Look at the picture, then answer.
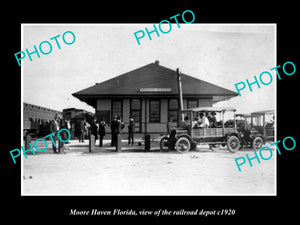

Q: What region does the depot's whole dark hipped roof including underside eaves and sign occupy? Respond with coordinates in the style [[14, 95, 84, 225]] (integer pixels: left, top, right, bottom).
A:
[[72, 61, 238, 107]]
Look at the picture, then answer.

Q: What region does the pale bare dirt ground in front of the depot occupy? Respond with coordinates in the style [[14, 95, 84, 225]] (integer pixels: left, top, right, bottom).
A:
[[21, 137, 276, 196]]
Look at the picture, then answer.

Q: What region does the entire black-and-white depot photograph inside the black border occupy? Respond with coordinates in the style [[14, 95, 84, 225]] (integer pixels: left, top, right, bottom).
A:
[[21, 23, 276, 196]]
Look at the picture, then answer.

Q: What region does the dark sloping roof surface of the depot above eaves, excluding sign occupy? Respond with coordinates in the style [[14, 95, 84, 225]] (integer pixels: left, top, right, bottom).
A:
[[73, 63, 237, 97]]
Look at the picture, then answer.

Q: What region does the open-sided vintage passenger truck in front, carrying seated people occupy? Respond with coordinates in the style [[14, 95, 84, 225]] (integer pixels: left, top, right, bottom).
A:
[[160, 107, 241, 153]]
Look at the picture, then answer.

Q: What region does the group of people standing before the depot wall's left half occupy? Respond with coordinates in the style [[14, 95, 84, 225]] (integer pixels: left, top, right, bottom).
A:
[[79, 116, 135, 147]]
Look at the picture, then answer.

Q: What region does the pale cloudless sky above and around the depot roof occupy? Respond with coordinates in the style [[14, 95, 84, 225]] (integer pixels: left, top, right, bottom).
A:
[[22, 22, 277, 113]]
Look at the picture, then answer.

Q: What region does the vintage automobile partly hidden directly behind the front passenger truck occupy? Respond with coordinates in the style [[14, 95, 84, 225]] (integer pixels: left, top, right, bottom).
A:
[[235, 113, 265, 150]]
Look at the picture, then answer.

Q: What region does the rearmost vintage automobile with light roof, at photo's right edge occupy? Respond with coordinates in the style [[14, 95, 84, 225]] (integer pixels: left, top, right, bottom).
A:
[[251, 110, 275, 141]]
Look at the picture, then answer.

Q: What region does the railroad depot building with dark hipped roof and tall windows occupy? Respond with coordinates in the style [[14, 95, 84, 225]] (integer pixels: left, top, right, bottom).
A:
[[72, 61, 238, 133]]
